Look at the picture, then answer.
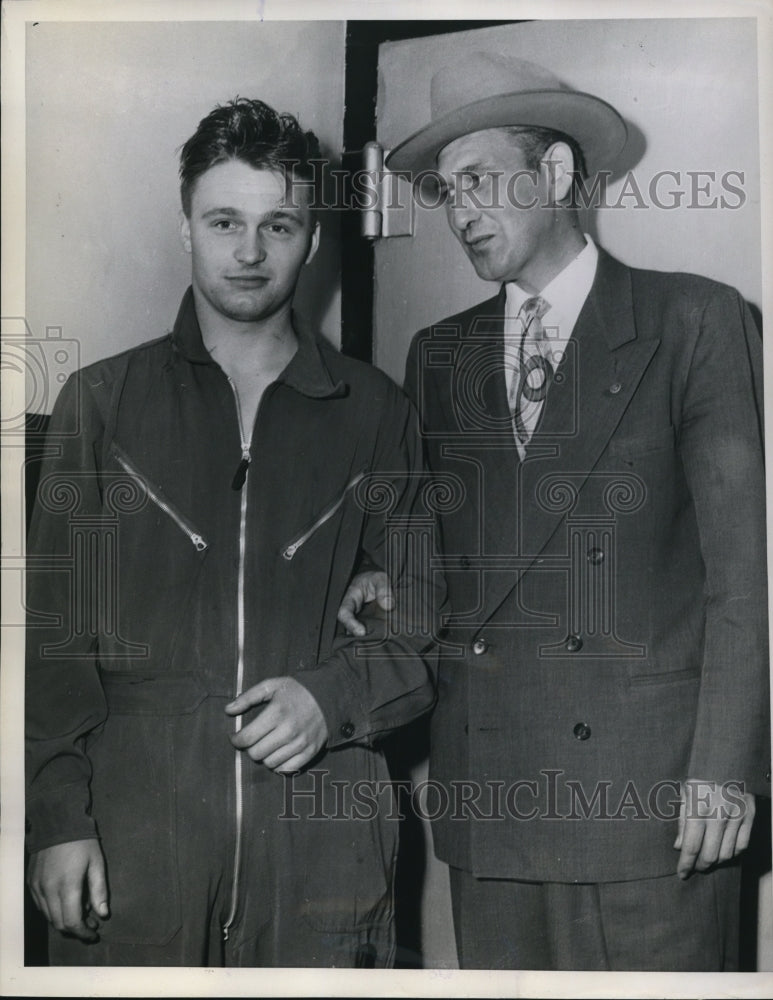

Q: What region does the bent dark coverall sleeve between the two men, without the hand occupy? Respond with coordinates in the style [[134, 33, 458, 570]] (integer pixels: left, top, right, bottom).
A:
[[296, 387, 445, 747]]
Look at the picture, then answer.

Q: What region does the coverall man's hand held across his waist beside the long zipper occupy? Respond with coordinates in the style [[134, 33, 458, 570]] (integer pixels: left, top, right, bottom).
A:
[[225, 677, 328, 774]]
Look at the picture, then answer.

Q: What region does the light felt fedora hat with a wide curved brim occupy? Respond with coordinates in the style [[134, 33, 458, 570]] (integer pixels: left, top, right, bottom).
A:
[[386, 52, 627, 174]]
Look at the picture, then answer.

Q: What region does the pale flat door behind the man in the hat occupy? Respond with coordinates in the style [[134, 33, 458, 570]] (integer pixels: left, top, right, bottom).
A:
[[373, 13, 773, 968]]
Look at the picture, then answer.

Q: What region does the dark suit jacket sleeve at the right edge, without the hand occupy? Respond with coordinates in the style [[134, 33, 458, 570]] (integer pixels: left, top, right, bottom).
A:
[[679, 287, 770, 794]]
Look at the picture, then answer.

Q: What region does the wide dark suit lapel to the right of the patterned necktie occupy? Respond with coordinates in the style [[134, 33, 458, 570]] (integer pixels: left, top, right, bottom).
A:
[[483, 250, 659, 618]]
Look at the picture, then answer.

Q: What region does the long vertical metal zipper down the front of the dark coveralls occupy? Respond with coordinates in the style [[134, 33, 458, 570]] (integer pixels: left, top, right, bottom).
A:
[[223, 376, 253, 941]]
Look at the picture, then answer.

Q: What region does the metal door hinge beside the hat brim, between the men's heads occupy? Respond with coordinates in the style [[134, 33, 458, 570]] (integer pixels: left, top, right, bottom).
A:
[[357, 142, 414, 240]]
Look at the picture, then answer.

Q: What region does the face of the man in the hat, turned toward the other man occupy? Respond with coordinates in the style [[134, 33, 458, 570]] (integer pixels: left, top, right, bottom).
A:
[[438, 129, 558, 291]]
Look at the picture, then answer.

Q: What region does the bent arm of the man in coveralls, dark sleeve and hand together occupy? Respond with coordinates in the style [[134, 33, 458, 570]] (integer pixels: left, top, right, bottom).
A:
[[227, 389, 444, 771]]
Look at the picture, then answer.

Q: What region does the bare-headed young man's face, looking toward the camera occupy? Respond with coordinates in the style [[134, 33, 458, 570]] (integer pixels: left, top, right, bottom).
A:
[[182, 160, 319, 323]]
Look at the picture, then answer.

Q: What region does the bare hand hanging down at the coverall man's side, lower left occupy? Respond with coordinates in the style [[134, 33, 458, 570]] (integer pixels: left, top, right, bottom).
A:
[[27, 840, 110, 941]]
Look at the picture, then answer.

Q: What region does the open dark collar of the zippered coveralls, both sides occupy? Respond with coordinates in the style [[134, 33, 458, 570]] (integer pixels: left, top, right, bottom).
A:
[[172, 288, 347, 398]]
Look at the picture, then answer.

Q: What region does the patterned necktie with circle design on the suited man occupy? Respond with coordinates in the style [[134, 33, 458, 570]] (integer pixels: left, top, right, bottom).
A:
[[509, 295, 553, 459]]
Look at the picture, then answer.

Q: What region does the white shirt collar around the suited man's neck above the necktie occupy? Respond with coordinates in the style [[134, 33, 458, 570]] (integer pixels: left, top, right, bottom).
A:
[[505, 233, 599, 354]]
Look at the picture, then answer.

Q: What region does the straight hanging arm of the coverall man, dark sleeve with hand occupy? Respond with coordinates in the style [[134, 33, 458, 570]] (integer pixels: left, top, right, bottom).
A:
[[26, 374, 107, 908]]
